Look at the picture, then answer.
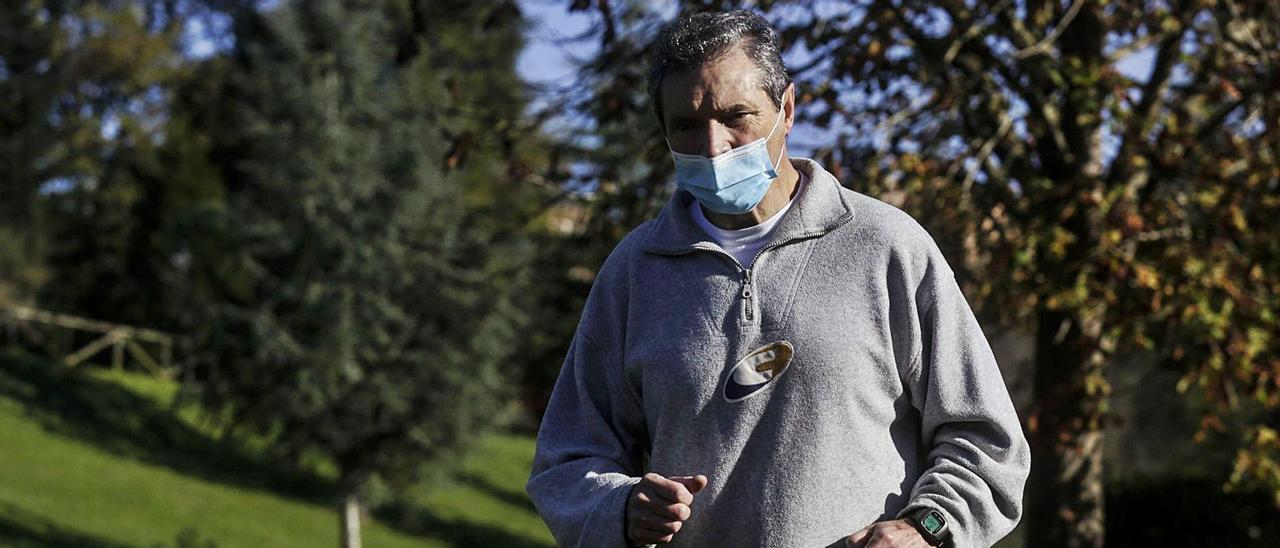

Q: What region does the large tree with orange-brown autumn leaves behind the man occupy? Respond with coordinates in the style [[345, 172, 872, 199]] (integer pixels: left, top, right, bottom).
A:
[[573, 0, 1280, 545]]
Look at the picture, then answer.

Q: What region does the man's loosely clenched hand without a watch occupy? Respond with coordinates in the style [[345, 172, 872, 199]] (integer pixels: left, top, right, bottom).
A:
[[626, 472, 707, 545]]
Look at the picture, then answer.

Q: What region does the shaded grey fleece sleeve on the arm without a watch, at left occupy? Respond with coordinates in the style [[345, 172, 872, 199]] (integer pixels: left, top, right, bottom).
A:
[[525, 326, 648, 548]]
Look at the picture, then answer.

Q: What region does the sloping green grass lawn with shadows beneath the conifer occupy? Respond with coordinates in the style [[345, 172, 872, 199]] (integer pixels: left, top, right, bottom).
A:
[[0, 352, 552, 548]]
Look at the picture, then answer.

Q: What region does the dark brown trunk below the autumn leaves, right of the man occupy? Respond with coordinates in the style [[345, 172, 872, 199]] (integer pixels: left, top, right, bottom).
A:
[[1027, 311, 1110, 548]]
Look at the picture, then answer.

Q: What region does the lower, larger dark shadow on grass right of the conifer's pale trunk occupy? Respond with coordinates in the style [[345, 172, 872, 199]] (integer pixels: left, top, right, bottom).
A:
[[372, 503, 548, 548]]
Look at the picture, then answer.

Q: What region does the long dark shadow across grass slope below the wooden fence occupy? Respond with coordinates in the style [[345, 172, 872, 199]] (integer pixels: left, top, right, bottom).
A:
[[0, 351, 334, 504]]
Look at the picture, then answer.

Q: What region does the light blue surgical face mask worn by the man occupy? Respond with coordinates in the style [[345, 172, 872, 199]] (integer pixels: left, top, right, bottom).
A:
[[668, 109, 786, 215]]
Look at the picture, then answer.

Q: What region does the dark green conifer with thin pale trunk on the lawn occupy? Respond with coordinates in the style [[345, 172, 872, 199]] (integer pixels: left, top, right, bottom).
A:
[[189, 0, 529, 547]]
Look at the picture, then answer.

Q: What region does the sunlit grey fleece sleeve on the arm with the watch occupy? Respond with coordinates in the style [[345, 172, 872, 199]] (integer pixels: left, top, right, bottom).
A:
[[899, 251, 1030, 548]]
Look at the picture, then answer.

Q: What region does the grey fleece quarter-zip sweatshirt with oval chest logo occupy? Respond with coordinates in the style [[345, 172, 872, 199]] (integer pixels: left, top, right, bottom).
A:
[[526, 159, 1030, 547]]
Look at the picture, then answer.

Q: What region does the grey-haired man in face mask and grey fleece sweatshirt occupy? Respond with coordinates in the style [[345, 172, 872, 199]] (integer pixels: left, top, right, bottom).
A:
[[527, 12, 1030, 547]]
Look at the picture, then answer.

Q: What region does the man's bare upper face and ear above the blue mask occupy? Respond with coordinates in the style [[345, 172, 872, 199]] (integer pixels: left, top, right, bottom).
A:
[[662, 47, 792, 157]]
